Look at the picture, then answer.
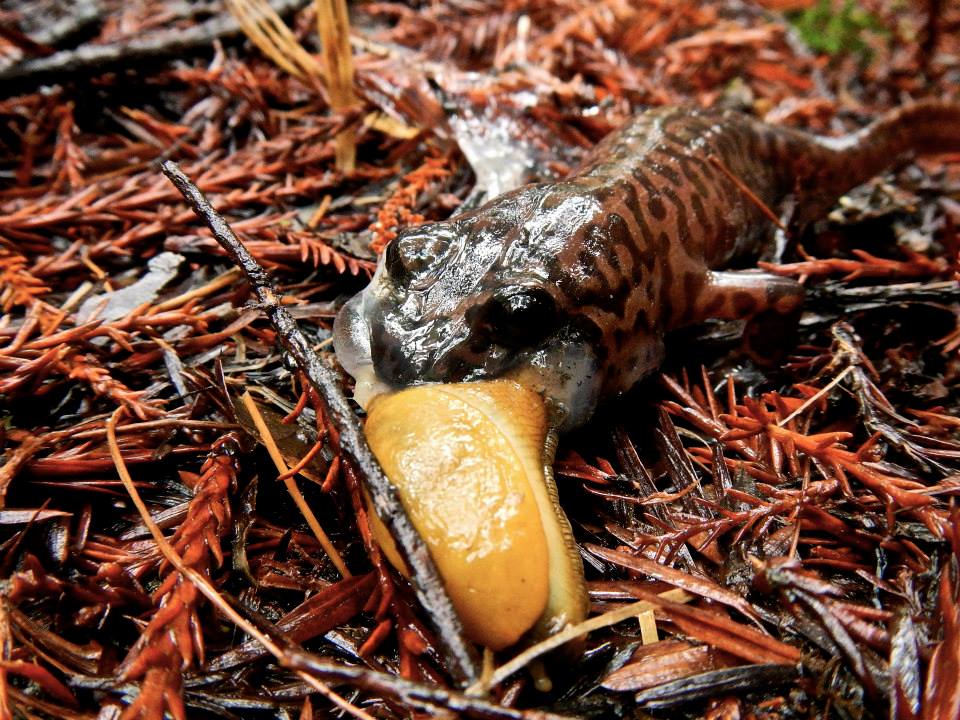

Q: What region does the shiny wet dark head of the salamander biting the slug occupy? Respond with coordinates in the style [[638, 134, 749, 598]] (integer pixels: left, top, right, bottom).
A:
[[334, 183, 664, 429]]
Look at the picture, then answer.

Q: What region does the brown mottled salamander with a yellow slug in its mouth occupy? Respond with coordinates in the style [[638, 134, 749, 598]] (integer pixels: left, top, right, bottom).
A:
[[334, 101, 960, 429]]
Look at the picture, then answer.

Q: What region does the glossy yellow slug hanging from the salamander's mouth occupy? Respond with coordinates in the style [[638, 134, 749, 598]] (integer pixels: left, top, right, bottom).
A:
[[366, 380, 586, 650]]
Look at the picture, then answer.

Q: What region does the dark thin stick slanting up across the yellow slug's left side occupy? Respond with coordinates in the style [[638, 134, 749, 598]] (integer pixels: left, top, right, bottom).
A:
[[161, 160, 479, 684]]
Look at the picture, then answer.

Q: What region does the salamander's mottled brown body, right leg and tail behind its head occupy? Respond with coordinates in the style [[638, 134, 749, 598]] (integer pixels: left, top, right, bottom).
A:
[[558, 102, 960, 392]]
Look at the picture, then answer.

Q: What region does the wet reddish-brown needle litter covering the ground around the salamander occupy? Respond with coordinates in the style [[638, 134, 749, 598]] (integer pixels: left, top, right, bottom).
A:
[[0, 0, 960, 720]]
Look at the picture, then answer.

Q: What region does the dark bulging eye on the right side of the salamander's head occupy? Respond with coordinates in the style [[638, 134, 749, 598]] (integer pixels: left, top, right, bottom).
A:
[[481, 289, 560, 348]]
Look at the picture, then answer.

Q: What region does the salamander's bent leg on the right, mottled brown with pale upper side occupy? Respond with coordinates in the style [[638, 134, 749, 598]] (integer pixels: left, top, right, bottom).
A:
[[698, 270, 804, 365]]
